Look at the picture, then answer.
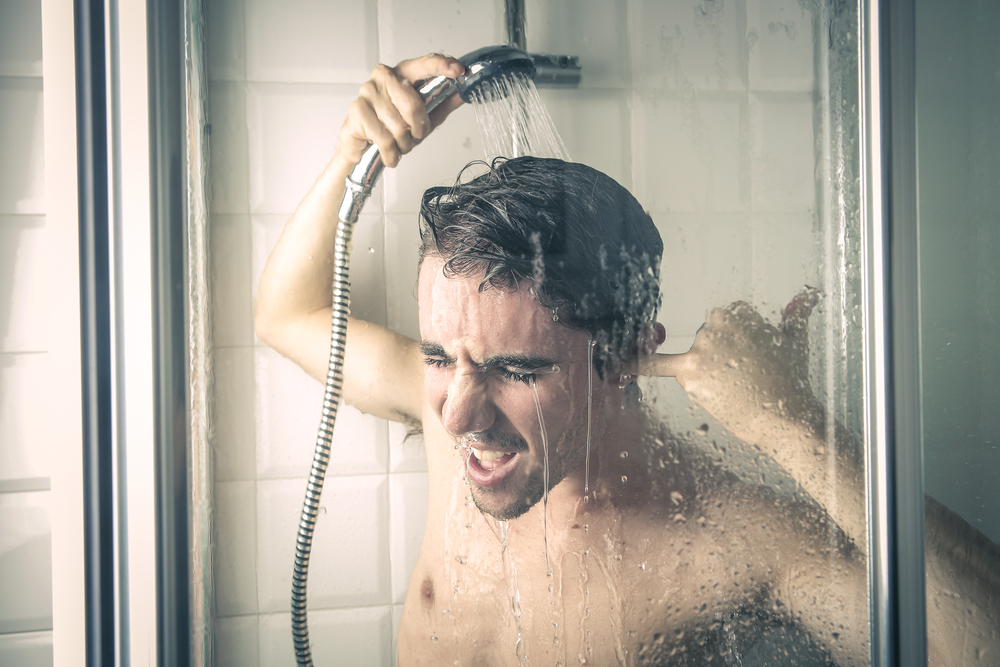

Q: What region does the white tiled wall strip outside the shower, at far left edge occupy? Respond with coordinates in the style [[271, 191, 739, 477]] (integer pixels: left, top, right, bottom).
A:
[[0, 0, 56, 667]]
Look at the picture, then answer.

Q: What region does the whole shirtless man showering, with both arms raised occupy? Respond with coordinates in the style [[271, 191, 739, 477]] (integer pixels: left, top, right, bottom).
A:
[[256, 55, 1000, 665]]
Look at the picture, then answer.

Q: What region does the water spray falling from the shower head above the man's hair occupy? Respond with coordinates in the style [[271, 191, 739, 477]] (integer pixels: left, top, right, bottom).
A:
[[472, 74, 569, 160]]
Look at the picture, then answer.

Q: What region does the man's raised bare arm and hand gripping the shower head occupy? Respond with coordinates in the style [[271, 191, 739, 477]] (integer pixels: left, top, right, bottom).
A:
[[254, 55, 465, 421]]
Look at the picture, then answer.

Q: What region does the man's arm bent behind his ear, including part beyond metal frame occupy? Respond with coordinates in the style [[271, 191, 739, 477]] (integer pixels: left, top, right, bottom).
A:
[[641, 290, 1000, 666]]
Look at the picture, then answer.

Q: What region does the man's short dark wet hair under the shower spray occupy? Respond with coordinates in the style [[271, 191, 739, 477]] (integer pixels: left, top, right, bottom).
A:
[[420, 156, 663, 377]]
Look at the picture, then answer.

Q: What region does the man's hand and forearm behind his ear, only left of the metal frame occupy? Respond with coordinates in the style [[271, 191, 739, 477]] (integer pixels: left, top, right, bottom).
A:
[[641, 289, 867, 551]]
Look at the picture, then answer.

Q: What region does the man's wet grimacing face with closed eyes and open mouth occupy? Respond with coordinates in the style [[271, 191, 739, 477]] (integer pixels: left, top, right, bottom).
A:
[[418, 256, 605, 520]]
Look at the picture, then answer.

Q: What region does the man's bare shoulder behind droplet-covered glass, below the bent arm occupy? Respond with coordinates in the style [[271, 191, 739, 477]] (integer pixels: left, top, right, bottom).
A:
[[620, 417, 867, 665]]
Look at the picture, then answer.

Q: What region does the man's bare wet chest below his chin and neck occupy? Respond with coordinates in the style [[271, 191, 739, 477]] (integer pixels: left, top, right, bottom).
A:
[[400, 488, 766, 665]]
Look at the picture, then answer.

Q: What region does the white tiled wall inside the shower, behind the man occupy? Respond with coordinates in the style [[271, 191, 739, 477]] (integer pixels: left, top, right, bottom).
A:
[[207, 0, 828, 666]]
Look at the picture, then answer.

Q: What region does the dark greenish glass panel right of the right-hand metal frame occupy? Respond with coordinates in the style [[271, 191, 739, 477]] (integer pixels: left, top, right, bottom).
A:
[[916, 0, 1000, 664]]
